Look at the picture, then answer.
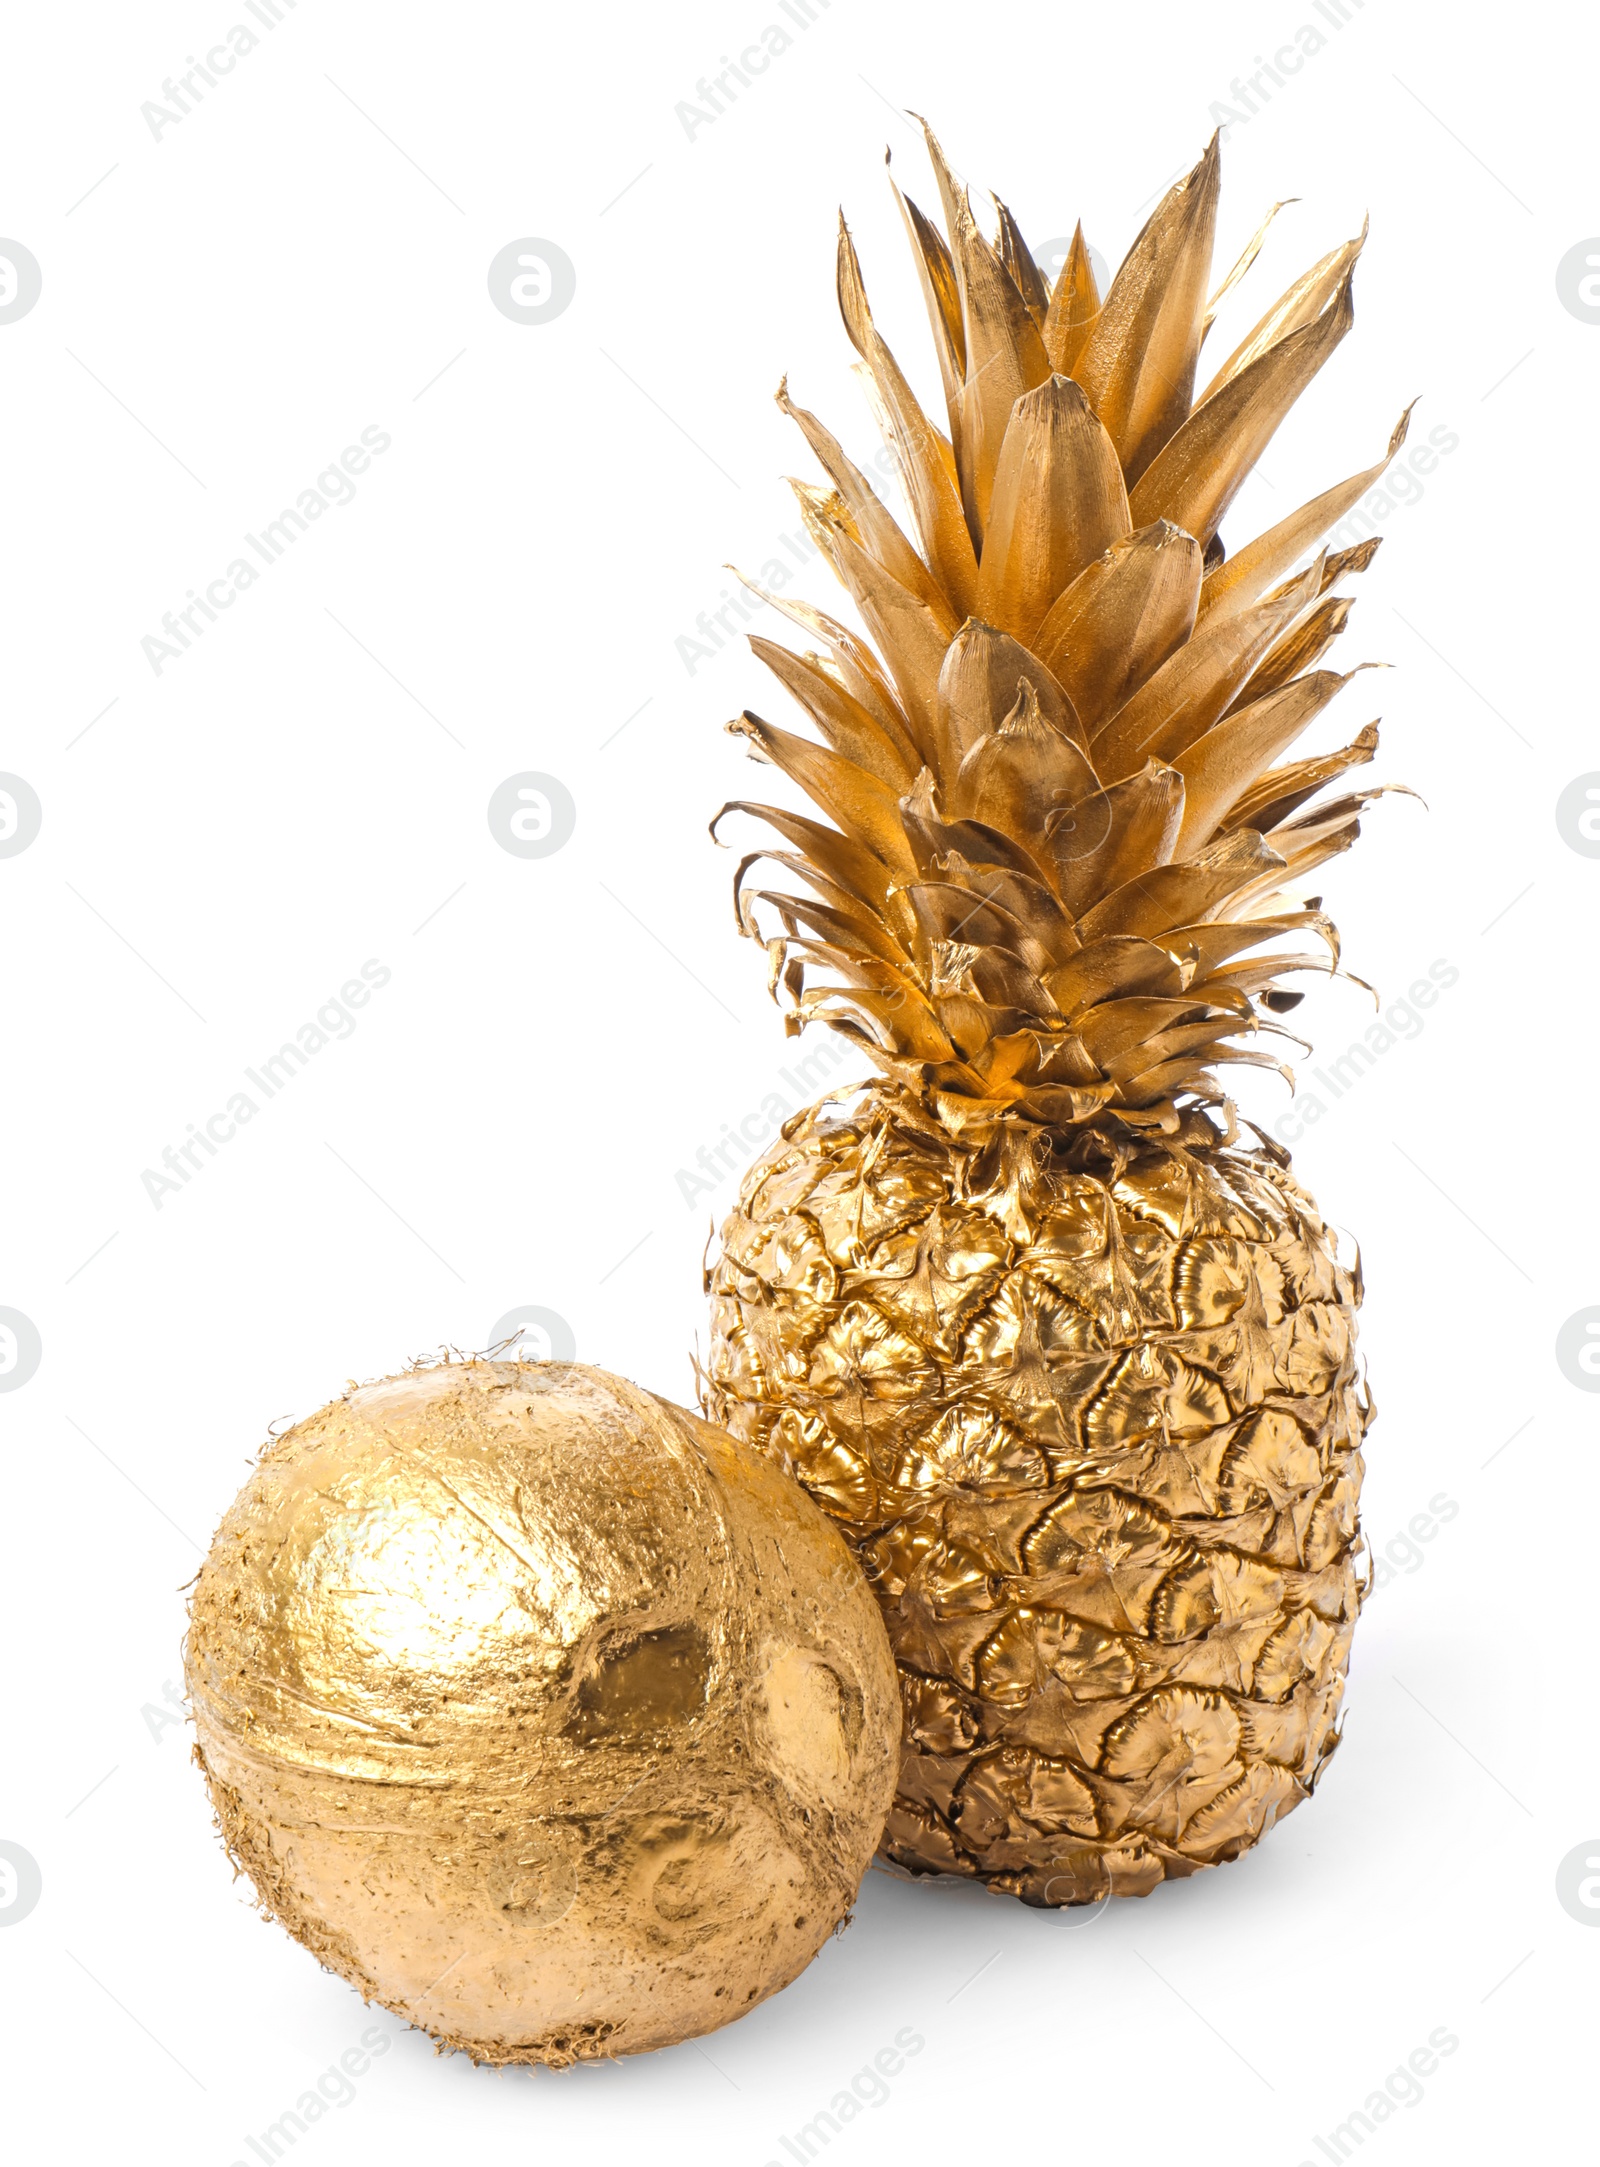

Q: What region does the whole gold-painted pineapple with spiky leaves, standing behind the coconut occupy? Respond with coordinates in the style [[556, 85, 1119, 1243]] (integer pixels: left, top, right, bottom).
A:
[[707, 137, 1405, 1905]]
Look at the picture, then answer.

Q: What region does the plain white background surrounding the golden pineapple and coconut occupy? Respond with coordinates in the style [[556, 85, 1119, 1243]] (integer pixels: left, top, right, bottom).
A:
[[0, 0, 1600, 2167]]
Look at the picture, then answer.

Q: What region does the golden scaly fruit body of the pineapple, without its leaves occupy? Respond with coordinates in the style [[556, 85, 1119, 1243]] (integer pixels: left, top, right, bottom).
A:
[[709, 1088, 1370, 1905]]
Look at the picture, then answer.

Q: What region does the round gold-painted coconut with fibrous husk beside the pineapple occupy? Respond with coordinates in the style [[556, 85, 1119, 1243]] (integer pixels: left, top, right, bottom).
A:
[[184, 1361, 900, 2065]]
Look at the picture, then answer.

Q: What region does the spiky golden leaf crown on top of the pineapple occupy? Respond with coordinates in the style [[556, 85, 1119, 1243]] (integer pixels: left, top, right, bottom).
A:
[[711, 128, 1409, 1136]]
